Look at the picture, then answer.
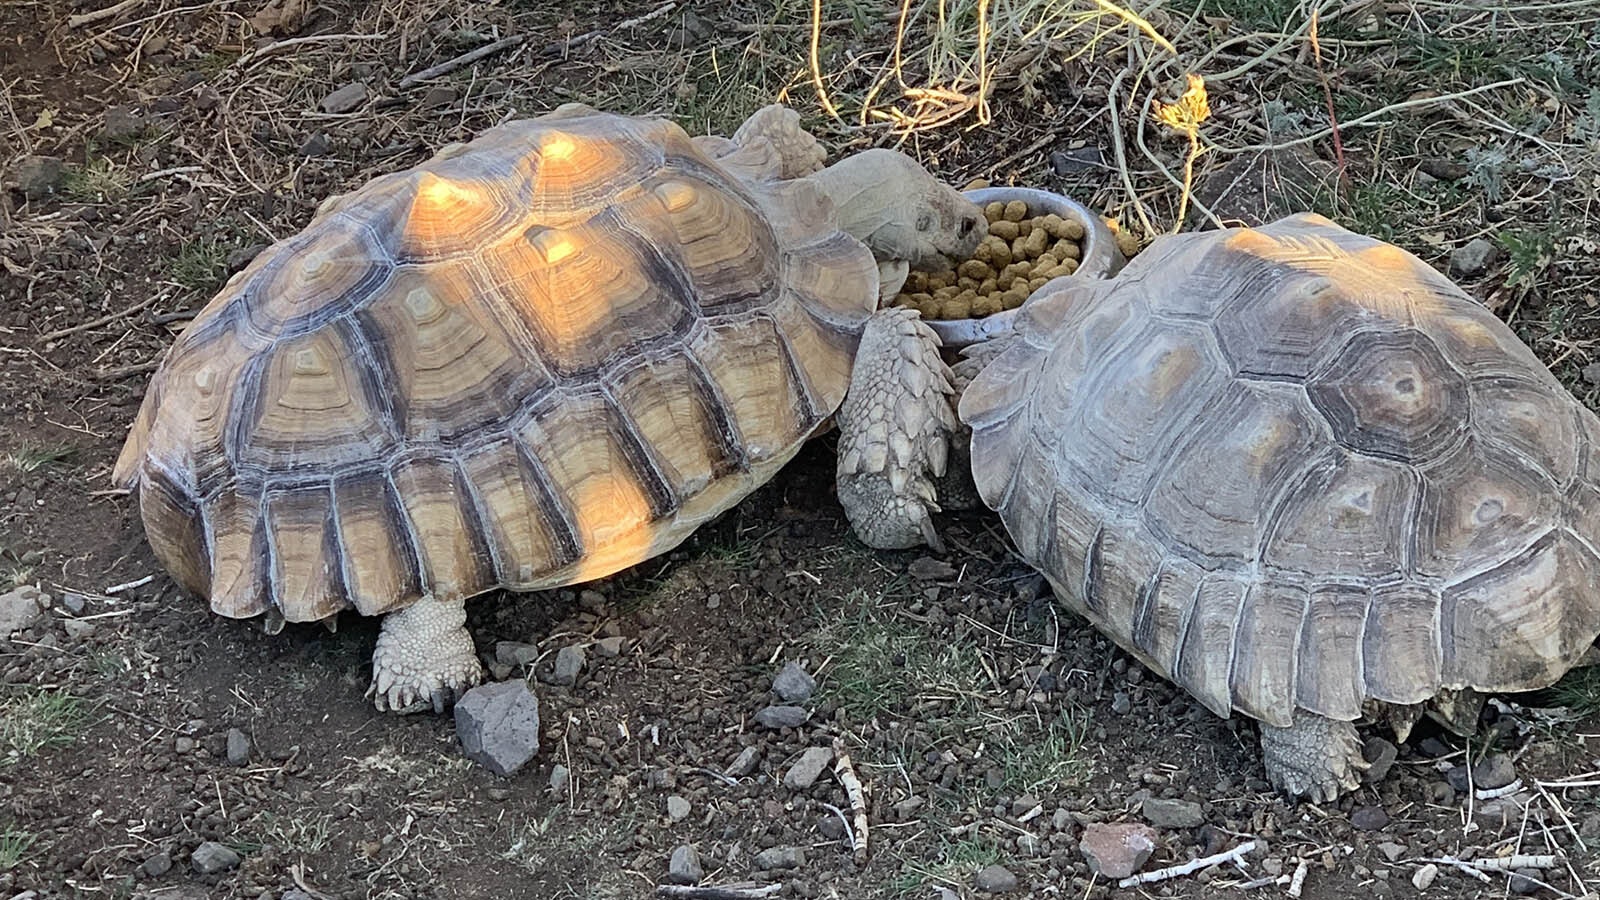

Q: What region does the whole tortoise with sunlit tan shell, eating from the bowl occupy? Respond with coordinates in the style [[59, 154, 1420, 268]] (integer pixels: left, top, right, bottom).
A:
[[114, 104, 986, 713]]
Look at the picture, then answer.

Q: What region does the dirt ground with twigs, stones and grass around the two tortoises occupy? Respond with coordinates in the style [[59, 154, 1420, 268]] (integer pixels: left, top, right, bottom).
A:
[[0, 0, 1600, 900]]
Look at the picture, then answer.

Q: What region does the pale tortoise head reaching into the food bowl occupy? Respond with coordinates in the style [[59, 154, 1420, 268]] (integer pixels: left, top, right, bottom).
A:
[[810, 149, 989, 269]]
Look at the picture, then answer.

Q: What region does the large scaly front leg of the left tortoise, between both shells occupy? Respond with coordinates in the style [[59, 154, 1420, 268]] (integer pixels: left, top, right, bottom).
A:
[[837, 307, 955, 549]]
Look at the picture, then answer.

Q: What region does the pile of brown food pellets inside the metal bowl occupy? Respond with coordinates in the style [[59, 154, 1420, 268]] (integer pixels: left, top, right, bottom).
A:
[[890, 200, 1083, 319]]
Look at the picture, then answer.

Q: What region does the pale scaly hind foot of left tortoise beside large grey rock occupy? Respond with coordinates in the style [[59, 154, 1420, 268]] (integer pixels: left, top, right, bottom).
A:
[[366, 597, 483, 713]]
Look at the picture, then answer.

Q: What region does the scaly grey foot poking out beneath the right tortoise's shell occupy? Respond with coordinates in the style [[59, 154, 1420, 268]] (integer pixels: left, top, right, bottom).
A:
[[1261, 709, 1366, 802]]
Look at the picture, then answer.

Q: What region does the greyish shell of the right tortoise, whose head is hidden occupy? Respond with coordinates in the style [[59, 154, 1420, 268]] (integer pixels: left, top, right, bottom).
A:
[[962, 215, 1600, 727]]
